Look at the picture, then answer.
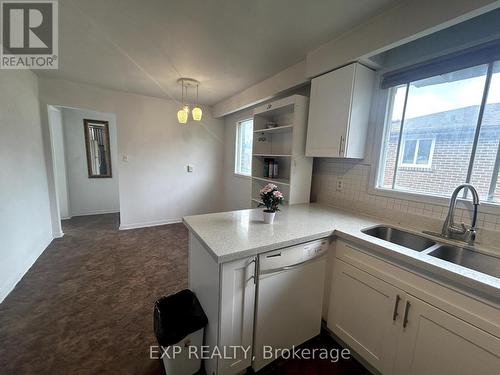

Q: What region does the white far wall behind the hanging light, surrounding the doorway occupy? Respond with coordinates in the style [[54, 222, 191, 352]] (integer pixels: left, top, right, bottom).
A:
[[39, 78, 224, 229]]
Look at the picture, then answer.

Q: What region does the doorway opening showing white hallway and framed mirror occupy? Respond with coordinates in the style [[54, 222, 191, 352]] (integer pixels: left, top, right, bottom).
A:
[[47, 105, 120, 234]]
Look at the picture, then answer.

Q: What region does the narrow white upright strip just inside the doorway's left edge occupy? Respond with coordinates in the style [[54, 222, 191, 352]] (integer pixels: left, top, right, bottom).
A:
[[48, 106, 71, 219]]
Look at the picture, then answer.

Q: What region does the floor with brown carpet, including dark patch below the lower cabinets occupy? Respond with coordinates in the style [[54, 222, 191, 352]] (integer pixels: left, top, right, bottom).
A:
[[0, 214, 368, 375]]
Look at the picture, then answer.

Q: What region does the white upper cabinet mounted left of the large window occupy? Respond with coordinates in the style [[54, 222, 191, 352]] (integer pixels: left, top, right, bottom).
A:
[[306, 63, 375, 159]]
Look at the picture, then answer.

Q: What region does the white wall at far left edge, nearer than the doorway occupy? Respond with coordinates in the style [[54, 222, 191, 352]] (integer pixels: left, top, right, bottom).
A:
[[0, 70, 52, 302]]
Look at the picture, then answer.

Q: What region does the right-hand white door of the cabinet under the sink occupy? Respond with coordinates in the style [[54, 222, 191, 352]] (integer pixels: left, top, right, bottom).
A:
[[394, 295, 500, 375]]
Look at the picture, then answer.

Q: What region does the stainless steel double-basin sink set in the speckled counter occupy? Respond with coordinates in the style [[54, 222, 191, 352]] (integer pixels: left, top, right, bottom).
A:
[[361, 225, 500, 278]]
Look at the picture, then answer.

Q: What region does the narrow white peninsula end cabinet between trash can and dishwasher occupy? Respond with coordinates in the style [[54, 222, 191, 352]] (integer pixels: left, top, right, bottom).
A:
[[189, 232, 256, 375]]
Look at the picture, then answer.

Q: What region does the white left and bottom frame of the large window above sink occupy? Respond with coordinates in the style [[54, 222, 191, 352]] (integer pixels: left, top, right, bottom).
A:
[[370, 62, 500, 215]]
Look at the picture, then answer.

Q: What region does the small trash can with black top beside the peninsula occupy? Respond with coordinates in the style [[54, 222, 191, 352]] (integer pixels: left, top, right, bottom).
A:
[[153, 289, 208, 375]]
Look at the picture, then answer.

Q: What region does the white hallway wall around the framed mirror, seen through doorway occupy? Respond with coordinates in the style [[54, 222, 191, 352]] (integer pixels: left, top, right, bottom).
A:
[[61, 108, 120, 216]]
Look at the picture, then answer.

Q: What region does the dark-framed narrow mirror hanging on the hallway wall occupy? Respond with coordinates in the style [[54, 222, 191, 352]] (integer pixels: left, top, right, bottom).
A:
[[83, 119, 112, 178]]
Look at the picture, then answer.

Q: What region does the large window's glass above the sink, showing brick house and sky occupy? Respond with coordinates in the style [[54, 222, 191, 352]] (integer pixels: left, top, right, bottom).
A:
[[378, 62, 500, 203]]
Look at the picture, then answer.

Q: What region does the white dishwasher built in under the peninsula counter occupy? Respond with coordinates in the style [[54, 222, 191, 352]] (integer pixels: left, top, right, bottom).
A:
[[252, 238, 330, 371]]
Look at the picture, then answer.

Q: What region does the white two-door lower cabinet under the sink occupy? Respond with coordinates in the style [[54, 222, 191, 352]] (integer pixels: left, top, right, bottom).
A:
[[327, 241, 500, 375]]
